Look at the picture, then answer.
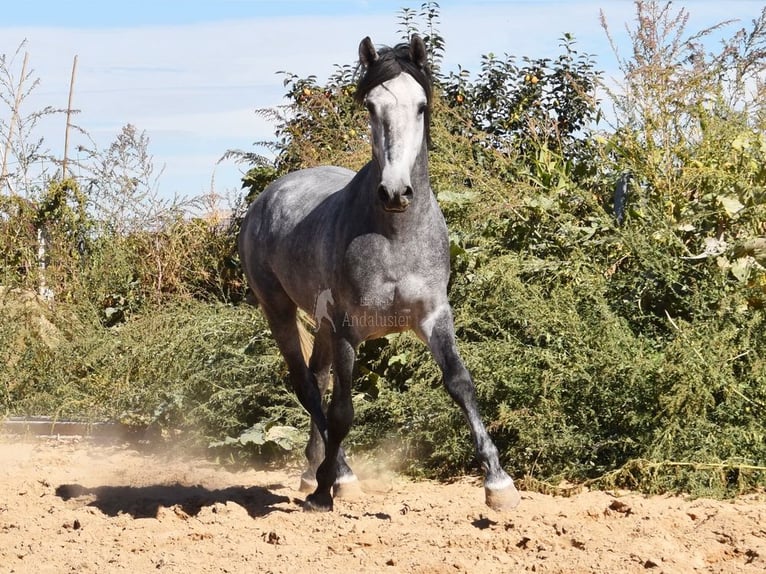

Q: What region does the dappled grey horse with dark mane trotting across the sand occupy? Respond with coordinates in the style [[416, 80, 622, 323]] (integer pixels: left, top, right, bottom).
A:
[[238, 35, 520, 511]]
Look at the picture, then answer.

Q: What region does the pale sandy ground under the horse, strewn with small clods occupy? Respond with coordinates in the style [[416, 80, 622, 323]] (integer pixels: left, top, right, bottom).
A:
[[0, 437, 766, 574]]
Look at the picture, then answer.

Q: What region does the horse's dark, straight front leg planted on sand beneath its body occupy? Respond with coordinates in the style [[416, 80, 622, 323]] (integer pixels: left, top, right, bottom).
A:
[[305, 336, 356, 512]]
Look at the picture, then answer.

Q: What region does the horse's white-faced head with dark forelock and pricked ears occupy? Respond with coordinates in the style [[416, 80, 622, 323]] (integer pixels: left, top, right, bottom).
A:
[[356, 35, 432, 212]]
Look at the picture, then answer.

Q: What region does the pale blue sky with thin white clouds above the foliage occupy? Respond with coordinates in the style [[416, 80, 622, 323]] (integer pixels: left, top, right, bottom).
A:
[[0, 0, 763, 204]]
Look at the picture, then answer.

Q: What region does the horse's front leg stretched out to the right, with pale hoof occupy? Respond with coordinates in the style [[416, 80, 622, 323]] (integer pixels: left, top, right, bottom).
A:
[[418, 304, 520, 510]]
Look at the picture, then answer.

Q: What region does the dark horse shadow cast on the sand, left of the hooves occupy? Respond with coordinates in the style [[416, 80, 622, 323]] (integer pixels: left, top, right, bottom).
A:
[[56, 483, 294, 518]]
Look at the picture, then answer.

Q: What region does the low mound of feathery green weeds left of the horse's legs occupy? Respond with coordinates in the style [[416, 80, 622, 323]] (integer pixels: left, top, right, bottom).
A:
[[4, 301, 307, 452]]
